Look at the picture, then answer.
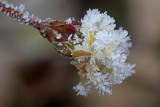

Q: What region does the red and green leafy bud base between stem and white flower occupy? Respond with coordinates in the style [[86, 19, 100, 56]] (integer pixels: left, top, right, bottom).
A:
[[39, 20, 83, 58]]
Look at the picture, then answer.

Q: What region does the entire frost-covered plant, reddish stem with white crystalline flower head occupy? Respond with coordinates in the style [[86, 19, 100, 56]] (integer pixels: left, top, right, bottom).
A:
[[0, 0, 135, 96]]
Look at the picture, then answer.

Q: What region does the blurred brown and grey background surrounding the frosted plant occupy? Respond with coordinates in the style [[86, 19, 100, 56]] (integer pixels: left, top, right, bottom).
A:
[[0, 0, 160, 107]]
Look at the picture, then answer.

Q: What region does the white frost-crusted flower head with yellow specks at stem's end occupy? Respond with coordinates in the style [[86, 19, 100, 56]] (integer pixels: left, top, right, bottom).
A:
[[72, 9, 135, 96]]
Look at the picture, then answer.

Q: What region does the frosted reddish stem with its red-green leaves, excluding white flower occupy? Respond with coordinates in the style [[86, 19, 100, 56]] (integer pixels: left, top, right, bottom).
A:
[[0, 0, 82, 57]]
